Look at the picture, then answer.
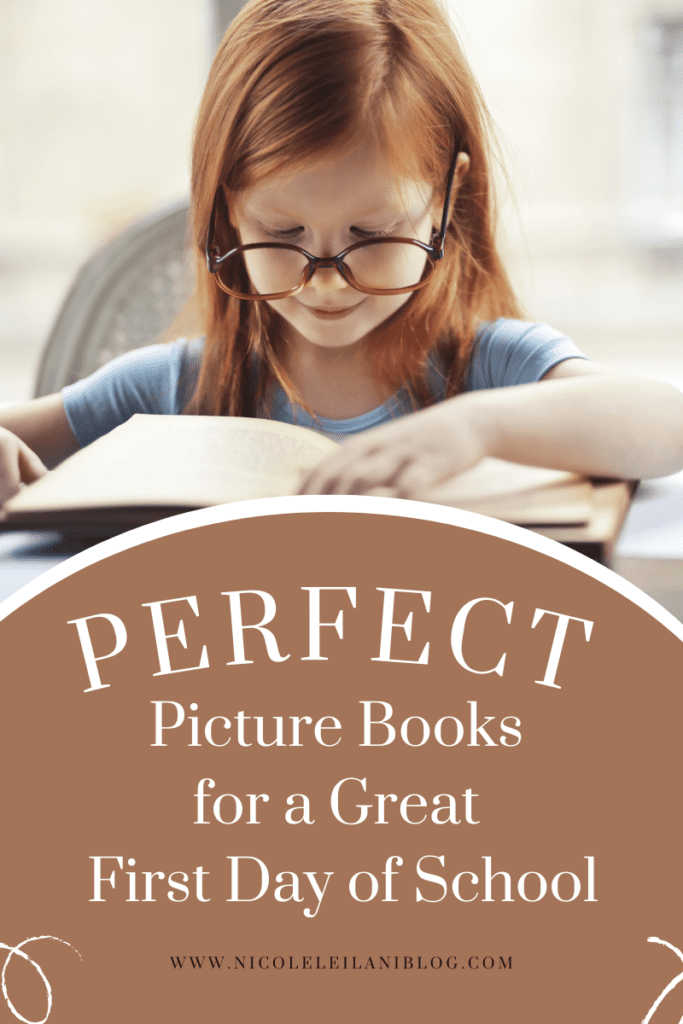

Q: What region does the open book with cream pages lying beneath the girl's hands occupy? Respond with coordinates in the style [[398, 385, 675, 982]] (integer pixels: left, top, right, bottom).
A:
[[2, 415, 592, 535]]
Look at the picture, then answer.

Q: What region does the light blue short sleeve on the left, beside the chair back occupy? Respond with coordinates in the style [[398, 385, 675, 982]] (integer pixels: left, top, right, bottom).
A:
[[61, 338, 203, 447]]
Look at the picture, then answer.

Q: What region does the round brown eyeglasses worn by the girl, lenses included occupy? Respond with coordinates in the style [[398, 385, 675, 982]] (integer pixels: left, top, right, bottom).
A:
[[206, 145, 460, 302]]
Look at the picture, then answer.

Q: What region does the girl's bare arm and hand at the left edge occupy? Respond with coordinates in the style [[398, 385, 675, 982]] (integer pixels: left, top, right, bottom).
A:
[[0, 394, 79, 504]]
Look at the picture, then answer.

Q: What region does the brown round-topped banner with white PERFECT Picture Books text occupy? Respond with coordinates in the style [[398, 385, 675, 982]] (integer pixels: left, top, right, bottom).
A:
[[0, 512, 683, 1024]]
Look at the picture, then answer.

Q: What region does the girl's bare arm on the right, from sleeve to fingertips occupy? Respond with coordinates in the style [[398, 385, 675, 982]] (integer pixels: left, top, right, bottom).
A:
[[302, 359, 683, 498]]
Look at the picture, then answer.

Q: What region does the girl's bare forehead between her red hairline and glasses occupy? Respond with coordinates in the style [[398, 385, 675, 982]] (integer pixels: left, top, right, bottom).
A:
[[237, 140, 432, 216]]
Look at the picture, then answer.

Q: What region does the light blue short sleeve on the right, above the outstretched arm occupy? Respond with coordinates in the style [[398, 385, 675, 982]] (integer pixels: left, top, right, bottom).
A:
[[466, 317, 586, 391]]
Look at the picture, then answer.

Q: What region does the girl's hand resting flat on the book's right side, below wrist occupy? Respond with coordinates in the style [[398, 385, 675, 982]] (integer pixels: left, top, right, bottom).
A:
[[300, 397, 488, 498]]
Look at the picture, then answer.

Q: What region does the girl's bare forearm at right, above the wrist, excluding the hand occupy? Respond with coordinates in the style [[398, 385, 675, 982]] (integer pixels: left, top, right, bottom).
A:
[[453, 374, 683, 479]]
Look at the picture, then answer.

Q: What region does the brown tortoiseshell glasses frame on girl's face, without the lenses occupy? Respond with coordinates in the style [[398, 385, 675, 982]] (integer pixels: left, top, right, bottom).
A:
[[206, 145, 460, 302]]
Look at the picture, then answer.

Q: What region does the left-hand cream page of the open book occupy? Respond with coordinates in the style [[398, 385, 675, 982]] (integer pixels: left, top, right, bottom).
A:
[[5, 415, 337, 513]]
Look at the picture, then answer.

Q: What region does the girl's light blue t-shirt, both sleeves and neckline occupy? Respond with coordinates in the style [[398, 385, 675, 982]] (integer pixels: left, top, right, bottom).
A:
[[62, 317, 585, 447]]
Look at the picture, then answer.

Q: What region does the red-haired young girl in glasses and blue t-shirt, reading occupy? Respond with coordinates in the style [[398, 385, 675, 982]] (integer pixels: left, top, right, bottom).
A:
[[0, 0, 683, 501]]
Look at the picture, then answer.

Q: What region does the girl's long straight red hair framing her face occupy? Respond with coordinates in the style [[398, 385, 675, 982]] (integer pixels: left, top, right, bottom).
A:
[[188, 0, 520, 416]]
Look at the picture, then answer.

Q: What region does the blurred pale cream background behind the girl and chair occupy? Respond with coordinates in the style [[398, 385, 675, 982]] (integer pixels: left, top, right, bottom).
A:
[[0, 0, 683, 401]]
